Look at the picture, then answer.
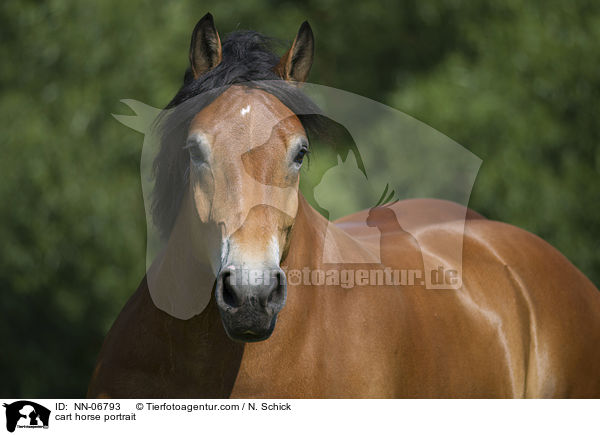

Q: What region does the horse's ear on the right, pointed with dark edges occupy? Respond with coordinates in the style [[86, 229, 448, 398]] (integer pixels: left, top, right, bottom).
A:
[[275, 21, 315, 83]]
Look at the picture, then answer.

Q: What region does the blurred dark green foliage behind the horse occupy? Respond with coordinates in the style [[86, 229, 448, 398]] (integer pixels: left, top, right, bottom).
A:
[[0, 0, 600, 397]]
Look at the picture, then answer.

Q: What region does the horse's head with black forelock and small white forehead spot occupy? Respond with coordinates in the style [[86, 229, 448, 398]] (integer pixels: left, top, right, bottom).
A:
[[153, 14, 313, 341]]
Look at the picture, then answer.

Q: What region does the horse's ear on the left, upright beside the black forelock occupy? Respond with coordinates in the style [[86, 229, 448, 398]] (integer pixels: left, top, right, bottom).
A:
[[190, 13, 221, 79]]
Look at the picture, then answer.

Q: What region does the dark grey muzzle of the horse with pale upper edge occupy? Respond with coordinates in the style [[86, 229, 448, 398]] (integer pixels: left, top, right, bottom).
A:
[[215, 265, 287, 342]]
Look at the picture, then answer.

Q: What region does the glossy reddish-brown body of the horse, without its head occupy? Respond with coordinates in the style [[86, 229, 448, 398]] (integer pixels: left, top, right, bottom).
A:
[[88, 199, 600, 398]]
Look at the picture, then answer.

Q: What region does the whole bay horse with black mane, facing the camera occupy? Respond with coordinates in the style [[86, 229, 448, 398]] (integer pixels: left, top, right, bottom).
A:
[[88, 14, 600, 398]]
